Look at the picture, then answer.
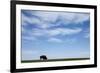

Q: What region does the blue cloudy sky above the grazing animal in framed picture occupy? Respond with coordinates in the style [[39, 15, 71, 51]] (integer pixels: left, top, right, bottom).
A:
[[21, 10, 90, 60]]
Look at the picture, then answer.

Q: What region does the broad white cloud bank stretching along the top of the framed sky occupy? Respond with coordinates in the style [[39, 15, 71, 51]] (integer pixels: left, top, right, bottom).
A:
[[22, 11, 89, 29]]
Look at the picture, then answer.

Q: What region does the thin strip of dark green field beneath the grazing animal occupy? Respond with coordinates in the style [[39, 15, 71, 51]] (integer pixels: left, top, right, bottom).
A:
[[21, 58, 90, 63]]
